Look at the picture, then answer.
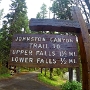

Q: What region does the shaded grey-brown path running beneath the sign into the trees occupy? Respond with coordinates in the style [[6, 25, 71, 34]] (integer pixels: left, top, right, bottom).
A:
[[0, 72, 58, 90]]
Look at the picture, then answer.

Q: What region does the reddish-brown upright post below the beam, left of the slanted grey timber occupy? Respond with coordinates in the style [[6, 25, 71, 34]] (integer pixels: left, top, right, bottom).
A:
[[78, 34, 90, 90]]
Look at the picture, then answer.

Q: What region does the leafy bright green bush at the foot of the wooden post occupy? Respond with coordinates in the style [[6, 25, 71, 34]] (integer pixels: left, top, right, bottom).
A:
[[61, 81, 82, 90]]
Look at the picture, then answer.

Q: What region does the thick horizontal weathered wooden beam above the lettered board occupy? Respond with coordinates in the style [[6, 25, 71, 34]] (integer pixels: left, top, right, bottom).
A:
[[29, 18, 90, 33]]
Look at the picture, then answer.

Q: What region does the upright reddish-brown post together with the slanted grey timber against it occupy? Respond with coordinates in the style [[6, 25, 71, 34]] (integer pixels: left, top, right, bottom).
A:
[[73, 7, 90, 90]]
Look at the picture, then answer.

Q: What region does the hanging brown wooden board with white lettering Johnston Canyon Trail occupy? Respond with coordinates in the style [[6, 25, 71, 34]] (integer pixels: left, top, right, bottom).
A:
[[9, 34, 79, 68]]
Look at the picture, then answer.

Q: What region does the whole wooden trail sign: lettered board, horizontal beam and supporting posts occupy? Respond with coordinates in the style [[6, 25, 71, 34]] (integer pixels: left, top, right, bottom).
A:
[[9, 7, 90, 90]]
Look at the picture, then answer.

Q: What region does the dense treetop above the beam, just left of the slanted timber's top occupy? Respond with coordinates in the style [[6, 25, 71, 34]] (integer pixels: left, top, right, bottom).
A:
[[50, 0, 71, 20]]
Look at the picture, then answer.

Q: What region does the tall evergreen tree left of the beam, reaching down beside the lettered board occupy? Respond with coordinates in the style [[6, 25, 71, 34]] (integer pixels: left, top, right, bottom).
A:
[[0, 0, 29, 65]]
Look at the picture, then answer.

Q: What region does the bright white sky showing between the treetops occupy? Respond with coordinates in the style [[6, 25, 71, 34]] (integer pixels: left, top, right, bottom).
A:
[[0, 0, 51, 19]]
